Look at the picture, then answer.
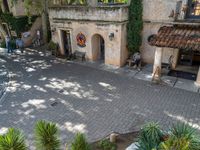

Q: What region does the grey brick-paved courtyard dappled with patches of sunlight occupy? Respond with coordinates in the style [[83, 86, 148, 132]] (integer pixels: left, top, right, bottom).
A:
[[0, 52, 200, 148]]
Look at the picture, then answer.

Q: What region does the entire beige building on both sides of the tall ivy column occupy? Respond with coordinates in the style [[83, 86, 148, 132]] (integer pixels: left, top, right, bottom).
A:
[[49, 0, 200, 85]]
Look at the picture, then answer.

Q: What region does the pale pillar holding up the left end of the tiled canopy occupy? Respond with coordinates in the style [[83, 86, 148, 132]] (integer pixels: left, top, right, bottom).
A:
[[153, 47, 163, 80]]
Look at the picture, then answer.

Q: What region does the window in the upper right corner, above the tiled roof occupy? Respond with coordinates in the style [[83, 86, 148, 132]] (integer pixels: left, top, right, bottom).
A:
[[188, 0, 200, 19]]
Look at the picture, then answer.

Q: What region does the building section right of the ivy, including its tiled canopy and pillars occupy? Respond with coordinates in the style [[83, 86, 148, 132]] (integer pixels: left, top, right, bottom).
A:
[[141, 0, 200, 85]]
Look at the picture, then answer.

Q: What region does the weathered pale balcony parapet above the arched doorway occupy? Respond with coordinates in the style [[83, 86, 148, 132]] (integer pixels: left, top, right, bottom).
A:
[[49, 4, 128, 22]]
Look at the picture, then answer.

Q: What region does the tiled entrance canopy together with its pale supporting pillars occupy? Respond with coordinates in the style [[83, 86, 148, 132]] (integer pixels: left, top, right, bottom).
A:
[[148, 25, 200, 86]]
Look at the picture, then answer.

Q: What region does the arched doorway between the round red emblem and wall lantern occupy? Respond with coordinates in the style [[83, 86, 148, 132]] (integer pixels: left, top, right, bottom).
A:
[[92, 34, 105, 62]]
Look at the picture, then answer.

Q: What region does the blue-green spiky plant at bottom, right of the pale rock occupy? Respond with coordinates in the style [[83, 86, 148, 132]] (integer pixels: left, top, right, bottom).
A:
[[137, 122, 163, 150]]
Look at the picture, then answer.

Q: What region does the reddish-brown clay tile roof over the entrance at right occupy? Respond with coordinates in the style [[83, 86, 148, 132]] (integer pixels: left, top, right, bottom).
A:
[[148, 25, 200, 51]]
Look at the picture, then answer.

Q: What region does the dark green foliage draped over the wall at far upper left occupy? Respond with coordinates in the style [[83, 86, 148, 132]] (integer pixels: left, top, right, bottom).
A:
[[0, 13, 36, 35]]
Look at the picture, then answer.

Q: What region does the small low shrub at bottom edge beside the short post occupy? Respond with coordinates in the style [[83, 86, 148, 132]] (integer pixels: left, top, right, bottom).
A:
[[98, 139, 117, 150]]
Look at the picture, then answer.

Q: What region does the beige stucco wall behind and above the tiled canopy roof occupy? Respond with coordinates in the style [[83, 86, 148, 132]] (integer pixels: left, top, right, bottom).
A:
[[141, 0, 187, 63]]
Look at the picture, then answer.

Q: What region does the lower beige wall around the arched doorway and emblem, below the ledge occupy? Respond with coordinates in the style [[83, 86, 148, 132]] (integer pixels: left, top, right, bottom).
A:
[[51, 21, 127, 66]]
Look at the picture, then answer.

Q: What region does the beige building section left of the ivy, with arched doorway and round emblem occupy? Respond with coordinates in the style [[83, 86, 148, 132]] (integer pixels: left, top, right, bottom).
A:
[[49, 0, 128, 66]]
